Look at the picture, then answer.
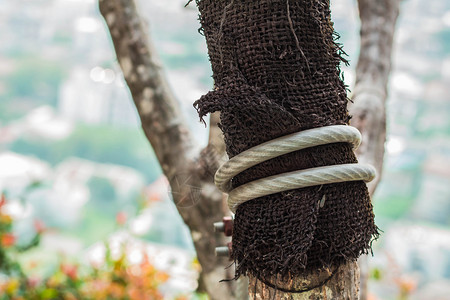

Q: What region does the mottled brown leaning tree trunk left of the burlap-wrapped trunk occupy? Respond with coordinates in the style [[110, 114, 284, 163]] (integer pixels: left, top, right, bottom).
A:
[[99, 0, 233, 299]]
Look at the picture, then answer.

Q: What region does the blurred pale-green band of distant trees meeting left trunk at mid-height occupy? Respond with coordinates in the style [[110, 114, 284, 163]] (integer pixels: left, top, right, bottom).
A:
[[10, 125, 161, 182]]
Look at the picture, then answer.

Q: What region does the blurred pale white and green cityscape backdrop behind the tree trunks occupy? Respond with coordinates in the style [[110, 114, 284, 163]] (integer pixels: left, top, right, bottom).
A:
[[0, 0, 450, 300]]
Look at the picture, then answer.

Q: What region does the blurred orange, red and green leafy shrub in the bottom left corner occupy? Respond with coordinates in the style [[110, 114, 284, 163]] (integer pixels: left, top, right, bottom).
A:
[[0, 194, 190, 300]]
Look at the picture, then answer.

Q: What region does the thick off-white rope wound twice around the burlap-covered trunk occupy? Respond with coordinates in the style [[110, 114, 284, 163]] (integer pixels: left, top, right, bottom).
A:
[[214, 125, 375, 212]]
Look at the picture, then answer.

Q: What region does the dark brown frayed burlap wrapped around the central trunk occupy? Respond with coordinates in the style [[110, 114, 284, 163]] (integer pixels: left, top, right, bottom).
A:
[[195, 0, 378, 277]]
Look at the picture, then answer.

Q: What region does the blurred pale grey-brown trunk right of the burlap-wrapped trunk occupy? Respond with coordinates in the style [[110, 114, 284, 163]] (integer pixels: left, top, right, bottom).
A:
[[349, 0, 400, 300]]
